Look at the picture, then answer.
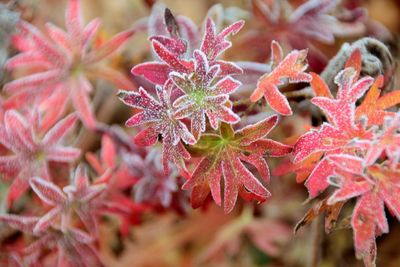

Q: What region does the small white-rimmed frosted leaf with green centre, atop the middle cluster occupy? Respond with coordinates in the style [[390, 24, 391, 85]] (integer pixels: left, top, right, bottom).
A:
[[170, 50, 240, 140]]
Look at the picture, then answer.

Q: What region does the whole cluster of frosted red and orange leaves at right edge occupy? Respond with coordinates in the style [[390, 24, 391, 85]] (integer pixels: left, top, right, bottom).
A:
[[292, 51, 400, 266]]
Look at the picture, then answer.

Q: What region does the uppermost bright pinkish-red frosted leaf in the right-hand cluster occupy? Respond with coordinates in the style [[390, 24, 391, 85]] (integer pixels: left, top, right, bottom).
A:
[[294, 68, 373, 162]]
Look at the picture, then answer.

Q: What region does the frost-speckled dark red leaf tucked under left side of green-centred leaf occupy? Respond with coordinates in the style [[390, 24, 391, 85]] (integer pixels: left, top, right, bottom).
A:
[[118, 80, 196, 174]]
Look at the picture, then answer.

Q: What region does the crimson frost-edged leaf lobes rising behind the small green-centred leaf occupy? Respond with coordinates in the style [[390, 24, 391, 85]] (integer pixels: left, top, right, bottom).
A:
[[131, 14, 244, 85]]
